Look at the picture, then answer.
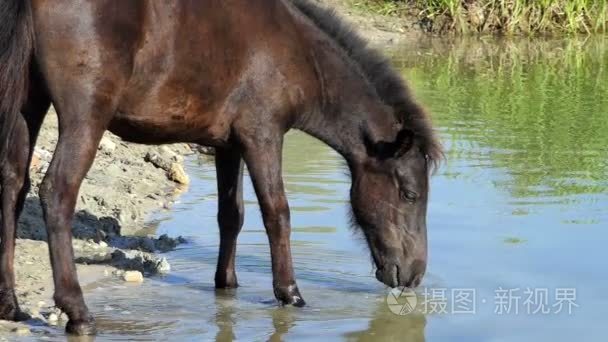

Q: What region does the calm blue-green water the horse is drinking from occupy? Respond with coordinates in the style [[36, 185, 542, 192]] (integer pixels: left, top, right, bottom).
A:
[[36, 38, 608, 341]]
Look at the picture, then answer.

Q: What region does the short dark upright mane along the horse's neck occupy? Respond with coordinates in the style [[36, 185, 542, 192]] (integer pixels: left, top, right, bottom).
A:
[[289, 0, 443, 169]]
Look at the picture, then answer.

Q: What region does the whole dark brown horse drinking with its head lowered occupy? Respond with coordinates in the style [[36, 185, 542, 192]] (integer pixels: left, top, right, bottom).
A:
[[0, 0, 441, 334]]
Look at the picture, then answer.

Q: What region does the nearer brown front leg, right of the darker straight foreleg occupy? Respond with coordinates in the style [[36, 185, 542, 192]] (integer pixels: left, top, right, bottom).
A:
[[241, 132, 306, 307]]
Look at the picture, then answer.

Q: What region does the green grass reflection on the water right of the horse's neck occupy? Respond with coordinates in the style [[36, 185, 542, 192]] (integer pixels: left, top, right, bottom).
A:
[[394, 37, 608, 201]]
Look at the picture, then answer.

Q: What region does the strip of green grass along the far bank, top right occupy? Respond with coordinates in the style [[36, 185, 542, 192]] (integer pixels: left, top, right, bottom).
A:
[[352, 0, 608, 35]]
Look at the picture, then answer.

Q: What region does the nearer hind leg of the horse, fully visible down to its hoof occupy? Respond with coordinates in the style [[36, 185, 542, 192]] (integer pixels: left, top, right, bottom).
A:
[[40, 110, 109, 335]]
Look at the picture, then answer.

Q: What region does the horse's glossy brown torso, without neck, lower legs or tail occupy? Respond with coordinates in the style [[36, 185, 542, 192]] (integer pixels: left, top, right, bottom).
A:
[[33, 0, 314, 145]]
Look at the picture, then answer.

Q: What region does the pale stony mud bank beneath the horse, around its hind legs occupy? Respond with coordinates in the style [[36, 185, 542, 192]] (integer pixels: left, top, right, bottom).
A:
[[0, 110, 192, 340]]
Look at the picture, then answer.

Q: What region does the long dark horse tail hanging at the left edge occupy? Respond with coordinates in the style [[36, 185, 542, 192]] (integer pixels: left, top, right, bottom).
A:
[[0, 0, 34, 165]]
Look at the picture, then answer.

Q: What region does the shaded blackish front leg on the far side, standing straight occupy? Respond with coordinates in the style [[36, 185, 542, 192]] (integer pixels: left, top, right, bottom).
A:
[[215, 148, 244, 288]]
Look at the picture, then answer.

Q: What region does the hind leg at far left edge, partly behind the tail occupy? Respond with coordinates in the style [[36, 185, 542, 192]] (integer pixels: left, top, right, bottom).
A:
[[0, 88, 50, 321]]
